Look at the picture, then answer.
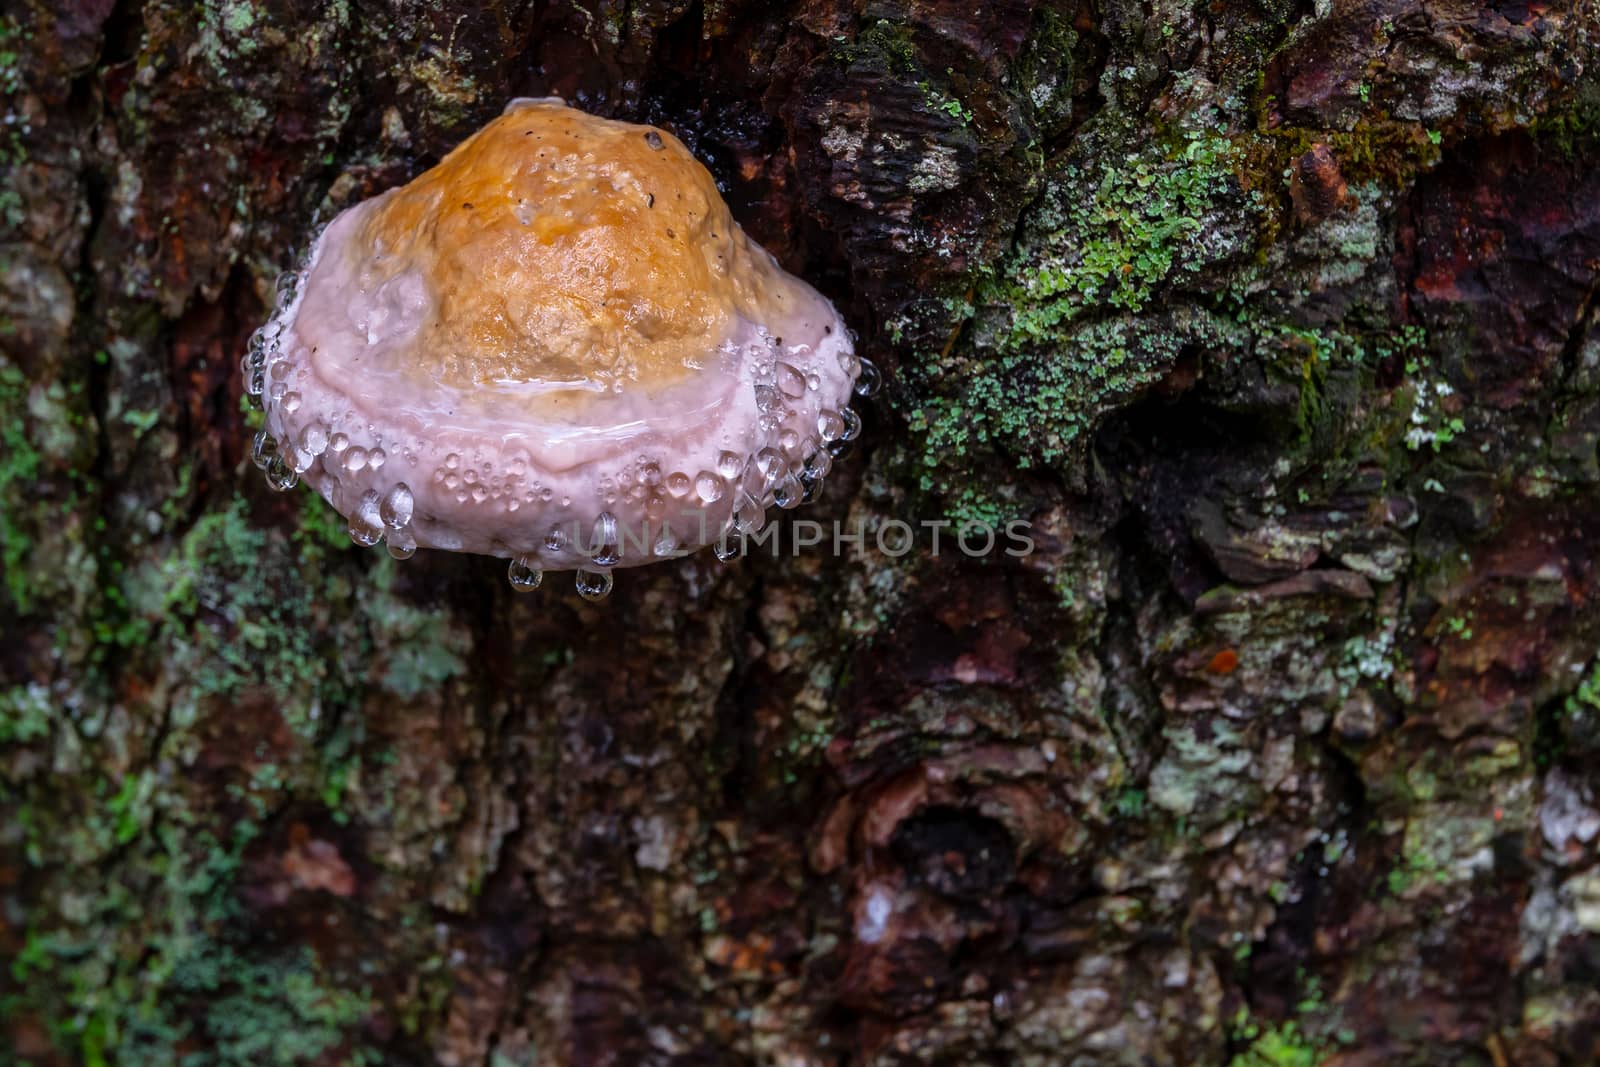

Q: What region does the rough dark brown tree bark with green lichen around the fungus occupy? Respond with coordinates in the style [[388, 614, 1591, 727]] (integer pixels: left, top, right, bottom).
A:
[[9, 0, 1600, 1067]]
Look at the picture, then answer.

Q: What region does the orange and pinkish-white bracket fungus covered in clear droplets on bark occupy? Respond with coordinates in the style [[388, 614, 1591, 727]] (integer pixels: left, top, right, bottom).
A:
[[246, 99, 859, 569]]
